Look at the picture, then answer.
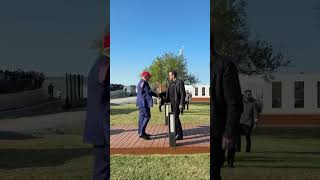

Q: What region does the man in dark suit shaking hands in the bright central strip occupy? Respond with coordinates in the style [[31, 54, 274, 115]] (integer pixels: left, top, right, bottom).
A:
[[166, 71, 186, 140]]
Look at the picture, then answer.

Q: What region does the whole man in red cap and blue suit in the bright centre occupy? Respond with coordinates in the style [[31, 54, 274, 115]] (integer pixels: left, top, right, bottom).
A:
[[137, 71, 157, 140]]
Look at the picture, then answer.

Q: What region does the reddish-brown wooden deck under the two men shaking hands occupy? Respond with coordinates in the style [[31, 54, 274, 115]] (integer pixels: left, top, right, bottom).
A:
[[110, 124, 210, 154]]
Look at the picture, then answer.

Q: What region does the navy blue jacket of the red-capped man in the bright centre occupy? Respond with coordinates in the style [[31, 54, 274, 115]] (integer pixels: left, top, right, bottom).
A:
[[137, 79, 157, 108]]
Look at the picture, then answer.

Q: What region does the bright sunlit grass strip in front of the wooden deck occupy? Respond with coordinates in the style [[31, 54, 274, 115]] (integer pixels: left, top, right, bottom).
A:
[[111, 154, 210, 180]]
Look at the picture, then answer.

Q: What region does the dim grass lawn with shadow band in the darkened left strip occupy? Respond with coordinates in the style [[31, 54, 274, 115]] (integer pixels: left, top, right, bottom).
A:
[[0, 129, 93, 180]]
